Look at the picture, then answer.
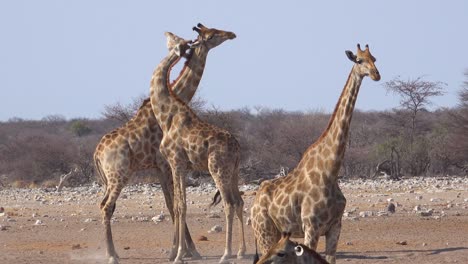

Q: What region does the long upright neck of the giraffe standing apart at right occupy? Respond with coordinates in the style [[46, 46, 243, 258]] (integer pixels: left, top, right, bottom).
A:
[[304, 66, 363, 181]]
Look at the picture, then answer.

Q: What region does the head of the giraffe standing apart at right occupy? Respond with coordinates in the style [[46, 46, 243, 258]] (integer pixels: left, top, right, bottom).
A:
[[346, 44, 380, 81]]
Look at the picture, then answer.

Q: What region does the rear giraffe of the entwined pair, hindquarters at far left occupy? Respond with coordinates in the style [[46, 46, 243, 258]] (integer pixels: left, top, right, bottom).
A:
[[94, 27, 236, 263]]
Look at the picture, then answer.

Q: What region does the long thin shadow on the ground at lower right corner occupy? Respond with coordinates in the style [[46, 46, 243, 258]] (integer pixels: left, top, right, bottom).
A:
[[336, 247, 468, 259]]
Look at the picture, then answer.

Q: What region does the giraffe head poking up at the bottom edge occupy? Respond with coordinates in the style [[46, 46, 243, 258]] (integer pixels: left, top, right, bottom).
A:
[[253, 232, 328, 264]]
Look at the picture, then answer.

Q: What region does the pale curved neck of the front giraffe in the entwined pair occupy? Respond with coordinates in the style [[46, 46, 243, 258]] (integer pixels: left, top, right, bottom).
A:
[[150, 51, 180, 132]]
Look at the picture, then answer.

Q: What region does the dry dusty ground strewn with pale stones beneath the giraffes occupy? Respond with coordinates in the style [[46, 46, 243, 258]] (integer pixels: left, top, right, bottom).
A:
[[0, 178, 468, 263]]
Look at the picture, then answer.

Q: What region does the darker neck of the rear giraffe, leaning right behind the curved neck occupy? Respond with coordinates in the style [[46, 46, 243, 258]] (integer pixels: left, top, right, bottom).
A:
[[172, 45, 209, 103]]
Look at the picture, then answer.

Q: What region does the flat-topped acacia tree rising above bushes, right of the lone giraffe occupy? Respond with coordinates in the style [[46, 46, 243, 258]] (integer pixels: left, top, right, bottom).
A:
[[383, 77, 446, 175]]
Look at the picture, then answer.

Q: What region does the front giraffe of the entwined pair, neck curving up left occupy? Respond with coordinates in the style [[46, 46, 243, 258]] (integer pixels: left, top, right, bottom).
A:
[[150, 24, 245, 263]]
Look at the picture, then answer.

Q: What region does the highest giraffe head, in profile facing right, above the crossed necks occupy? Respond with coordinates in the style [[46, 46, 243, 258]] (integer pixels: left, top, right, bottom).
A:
[[192, 23, 236, 50]]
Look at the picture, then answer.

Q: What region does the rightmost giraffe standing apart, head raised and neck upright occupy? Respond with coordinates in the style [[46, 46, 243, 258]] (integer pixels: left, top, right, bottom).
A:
[[251, 44, 380, 263]]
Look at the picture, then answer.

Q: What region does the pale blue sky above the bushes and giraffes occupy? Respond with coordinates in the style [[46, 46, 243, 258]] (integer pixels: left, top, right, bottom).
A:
[[0, 0, 468, 121]]
